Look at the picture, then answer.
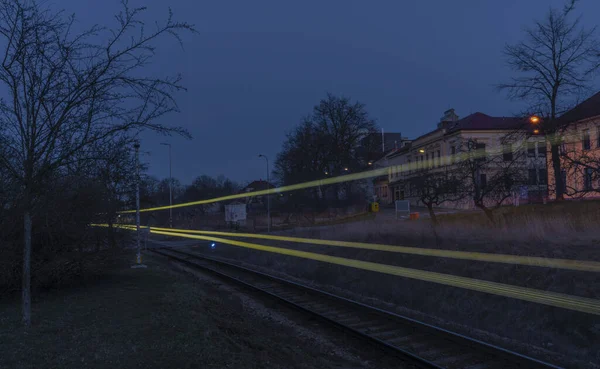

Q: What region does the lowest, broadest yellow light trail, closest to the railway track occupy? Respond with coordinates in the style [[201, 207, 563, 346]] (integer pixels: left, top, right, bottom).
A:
[[120, 228, 600, 315]]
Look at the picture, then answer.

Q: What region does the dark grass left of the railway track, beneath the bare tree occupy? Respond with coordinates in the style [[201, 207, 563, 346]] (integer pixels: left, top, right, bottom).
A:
[[0, 249, 398, 369]]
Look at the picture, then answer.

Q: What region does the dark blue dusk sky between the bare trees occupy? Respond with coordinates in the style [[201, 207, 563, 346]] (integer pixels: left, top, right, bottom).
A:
[[62, 0, 600, 184]]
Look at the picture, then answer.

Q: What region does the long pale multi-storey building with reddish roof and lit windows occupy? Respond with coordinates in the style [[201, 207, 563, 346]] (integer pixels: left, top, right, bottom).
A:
[[382, 109, 548, 208]]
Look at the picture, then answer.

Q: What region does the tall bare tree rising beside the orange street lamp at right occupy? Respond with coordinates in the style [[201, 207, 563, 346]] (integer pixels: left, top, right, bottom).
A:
[[498, 0, 600, 200]]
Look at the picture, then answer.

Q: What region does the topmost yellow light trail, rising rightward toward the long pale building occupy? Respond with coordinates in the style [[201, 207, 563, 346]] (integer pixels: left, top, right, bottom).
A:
[[118, 127, 580, 214]]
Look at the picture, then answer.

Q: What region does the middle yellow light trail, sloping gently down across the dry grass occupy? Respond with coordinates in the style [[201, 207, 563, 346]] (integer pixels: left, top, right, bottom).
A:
[[127, 226, 600, 273]]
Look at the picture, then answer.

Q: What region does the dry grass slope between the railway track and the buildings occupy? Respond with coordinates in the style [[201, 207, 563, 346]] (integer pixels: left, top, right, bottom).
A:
[[186, 202, 600, 367]]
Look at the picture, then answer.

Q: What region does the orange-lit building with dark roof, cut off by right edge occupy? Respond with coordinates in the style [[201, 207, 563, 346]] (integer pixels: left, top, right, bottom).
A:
[[547, 92, 600, 199]]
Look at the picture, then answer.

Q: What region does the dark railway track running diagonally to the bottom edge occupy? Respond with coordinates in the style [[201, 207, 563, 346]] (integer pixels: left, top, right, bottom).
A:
[[149, 248, 560, 369]]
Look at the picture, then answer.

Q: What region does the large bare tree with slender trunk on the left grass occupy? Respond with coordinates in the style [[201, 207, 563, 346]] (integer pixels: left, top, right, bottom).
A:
[[0, 0, 194, 326]]
